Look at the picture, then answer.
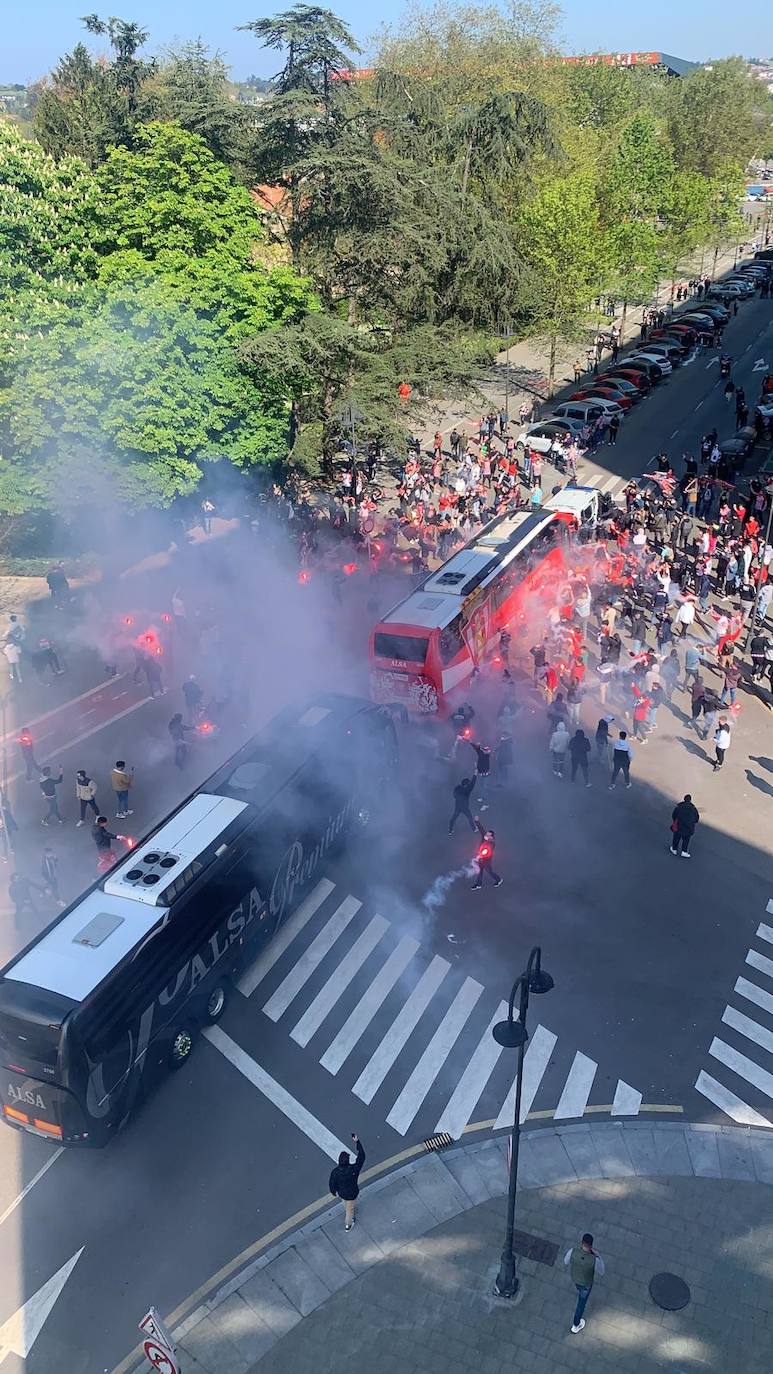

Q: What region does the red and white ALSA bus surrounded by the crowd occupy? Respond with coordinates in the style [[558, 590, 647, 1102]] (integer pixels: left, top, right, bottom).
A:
[[369, 486, 599, 716]]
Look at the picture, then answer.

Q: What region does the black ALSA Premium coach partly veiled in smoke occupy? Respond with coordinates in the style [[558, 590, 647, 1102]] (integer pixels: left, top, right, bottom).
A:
[[0, 695, 398, 1146]]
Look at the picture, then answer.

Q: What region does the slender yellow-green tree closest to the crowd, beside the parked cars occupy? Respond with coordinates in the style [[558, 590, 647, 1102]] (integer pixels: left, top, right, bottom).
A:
[[522, 173, 605, 396]]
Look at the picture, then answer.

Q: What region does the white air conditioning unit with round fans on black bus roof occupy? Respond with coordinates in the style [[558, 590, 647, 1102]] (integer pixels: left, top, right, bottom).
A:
[[104, 793, 246, 907]]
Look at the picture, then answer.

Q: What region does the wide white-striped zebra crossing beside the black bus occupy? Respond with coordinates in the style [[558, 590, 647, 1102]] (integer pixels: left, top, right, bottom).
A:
[[223, 878, 641, 1139]]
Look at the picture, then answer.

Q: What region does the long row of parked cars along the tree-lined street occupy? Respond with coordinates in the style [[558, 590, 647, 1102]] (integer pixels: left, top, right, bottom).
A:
[[516, 261, 769, 453]]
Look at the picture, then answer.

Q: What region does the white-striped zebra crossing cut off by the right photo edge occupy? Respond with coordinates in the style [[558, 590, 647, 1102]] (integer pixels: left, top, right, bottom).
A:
[[695, 899, 773, 1128]]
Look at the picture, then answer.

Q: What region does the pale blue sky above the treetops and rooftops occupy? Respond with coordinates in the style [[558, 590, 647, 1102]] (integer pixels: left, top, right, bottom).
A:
[[0, 0, 773, 85]]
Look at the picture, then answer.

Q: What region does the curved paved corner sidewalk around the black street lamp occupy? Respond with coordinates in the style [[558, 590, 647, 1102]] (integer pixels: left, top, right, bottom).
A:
[[168, 1123, 773, 1374]]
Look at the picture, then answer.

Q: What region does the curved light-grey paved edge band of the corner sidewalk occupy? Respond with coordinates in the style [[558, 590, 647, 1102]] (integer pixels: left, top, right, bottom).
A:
[[153, 1121, 773, 1374]]
